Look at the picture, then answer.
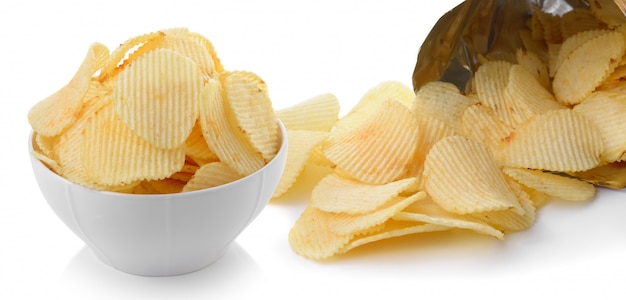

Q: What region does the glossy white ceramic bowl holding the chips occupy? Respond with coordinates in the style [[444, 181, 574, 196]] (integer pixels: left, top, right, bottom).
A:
[[28, 122, 287, 276]]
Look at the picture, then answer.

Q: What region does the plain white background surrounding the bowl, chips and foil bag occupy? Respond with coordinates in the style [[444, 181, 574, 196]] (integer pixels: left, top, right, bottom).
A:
[[0, 0, 626, 299]]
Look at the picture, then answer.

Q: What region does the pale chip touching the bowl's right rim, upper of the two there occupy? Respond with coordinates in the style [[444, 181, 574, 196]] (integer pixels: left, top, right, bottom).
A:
[[276, 93, 339, 131]]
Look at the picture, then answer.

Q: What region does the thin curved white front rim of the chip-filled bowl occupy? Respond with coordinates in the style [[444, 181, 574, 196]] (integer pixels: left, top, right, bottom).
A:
[[28, 119, 288, 200]]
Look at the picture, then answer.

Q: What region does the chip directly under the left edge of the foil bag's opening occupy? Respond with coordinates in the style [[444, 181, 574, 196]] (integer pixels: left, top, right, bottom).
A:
[[411, 81, 476, 131]]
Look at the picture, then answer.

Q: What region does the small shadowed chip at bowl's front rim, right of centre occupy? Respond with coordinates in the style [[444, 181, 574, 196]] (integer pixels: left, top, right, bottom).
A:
[[182, 162, 241, 192]]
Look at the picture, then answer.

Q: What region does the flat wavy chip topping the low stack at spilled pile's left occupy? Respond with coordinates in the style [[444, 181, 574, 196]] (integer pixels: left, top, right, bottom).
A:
[[309, 173, 417, 214]]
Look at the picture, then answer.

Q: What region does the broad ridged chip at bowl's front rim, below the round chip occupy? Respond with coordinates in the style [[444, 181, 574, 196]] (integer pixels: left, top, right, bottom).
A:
[[80, 105, 185, 185]]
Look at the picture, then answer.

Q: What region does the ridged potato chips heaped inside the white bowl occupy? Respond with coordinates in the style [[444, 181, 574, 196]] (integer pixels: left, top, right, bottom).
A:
[[28, 28, 283, 194]]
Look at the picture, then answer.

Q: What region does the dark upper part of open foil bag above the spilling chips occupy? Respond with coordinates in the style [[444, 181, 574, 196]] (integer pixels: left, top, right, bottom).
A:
[[413, 0, 626, 91]]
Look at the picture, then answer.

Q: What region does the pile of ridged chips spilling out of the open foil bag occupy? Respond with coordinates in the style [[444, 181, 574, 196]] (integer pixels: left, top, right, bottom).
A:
[[285, 5, 626, 260]]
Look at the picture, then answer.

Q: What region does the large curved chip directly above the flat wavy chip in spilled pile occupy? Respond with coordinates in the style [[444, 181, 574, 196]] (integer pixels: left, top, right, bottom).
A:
[[323, 100, 419, 184]]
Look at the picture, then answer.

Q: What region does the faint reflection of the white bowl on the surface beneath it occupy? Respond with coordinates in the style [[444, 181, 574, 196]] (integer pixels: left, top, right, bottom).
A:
[[58, 243, 263, 299]]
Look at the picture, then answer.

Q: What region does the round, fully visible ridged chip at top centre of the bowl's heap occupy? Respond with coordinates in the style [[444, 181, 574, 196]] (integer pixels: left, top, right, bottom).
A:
[[113, 49, 202, 149]]
